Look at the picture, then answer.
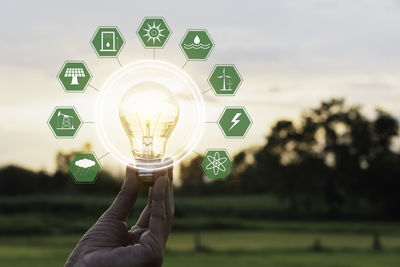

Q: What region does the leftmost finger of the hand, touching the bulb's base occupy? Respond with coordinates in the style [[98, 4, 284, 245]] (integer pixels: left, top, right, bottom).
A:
[[102, 166, 140, 221]]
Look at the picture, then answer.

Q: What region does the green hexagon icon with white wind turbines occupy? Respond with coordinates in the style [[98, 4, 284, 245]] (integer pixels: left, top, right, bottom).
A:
[[208, 65, 242, 95]]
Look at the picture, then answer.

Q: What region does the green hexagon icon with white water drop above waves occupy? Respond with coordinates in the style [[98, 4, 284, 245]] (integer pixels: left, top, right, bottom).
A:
[[180, 29, 214, 60]]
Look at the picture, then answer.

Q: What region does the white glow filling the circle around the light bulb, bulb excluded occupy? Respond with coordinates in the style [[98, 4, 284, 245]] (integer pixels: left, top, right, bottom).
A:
[[95, 60, 205, 170]]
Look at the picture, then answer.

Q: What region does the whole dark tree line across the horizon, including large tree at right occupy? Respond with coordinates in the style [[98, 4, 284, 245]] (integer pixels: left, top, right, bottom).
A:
[[0, 99, 400, 218]]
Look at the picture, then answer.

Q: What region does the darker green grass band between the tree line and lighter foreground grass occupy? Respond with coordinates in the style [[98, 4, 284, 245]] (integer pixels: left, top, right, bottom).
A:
[[0, 195, 400, 236]]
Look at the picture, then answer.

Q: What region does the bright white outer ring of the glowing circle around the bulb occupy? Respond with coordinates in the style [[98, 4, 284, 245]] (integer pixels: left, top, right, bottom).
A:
[[95, 60, 205, 170]]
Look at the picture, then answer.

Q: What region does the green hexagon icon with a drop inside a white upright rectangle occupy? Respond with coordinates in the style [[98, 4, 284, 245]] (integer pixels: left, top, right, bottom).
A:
[[90, 26, 125, 57]]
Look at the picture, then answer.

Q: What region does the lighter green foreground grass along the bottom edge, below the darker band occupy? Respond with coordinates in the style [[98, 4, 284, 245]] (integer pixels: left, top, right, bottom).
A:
[[0, 231, 400, 267]]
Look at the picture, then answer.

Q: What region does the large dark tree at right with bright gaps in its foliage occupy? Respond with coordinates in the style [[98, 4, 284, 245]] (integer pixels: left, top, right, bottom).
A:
[[246, 99, 400, 218]]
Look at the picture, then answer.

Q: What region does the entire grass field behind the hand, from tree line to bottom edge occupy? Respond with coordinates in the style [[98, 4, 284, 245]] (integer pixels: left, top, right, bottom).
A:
[[0, 195, 400, 267]]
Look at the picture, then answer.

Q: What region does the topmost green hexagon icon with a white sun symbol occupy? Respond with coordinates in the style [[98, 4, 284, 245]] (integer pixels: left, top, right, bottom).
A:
[[136, 17, 171, 48]]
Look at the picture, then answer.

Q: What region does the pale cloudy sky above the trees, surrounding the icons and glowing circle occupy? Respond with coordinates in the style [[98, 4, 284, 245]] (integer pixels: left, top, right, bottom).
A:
[[0, 0, 400, 175]]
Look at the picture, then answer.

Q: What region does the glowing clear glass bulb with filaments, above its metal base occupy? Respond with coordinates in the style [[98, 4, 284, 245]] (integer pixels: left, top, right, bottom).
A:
[[119, 82, 179, 160]]
